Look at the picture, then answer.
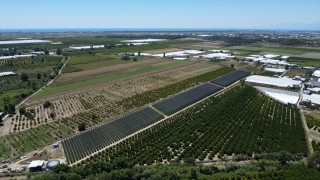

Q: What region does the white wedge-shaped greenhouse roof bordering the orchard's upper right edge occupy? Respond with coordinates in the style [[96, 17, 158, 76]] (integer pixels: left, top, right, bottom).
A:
[[254, 86, 300, 104]]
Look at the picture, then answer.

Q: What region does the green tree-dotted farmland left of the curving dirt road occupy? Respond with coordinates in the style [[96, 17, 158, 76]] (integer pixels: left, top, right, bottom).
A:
[[0, 56, 64, 111]]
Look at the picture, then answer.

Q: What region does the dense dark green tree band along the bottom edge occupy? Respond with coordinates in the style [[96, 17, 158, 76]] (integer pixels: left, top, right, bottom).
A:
[[28, 158, 320, 180]]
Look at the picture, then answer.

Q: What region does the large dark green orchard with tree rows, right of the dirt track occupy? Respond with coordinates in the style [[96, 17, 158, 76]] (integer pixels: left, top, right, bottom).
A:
[[73, 85, 308, 165]]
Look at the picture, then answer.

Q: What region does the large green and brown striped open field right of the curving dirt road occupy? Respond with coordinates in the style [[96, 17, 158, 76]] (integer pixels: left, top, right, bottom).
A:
[[35, 57, 190, 97]]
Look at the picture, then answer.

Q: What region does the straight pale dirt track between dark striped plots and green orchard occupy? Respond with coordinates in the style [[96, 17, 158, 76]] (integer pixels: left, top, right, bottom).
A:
[[65, 81, 240, 166]]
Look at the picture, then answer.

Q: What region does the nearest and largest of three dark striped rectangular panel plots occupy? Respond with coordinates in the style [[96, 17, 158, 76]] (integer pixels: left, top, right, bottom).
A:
[[62, 107, 164, 164]]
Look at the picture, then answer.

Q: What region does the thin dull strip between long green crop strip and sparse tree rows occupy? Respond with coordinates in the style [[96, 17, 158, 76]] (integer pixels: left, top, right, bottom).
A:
[[26, 62, 200, 104]]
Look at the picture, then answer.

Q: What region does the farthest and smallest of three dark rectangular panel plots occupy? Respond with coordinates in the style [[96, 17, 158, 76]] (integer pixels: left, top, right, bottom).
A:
[[210, 70, 251, 87]]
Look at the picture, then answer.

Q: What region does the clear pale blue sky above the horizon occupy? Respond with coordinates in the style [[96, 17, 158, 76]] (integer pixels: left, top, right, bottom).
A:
[[0, 0, 320, 31]]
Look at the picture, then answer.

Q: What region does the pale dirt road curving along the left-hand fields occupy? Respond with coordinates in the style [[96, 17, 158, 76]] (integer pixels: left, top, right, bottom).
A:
[[0, 56, 70, 136]]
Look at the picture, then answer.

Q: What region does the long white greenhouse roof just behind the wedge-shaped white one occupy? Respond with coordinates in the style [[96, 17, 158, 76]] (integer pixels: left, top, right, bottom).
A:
[[246, 75, 301, 87]]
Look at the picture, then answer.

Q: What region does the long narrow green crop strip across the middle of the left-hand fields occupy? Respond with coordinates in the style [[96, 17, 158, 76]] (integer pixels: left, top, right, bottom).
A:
[[34, 61, 189, 97]]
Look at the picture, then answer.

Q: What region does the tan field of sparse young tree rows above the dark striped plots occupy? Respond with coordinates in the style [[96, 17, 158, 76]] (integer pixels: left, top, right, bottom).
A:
[[11, 63, 231, 132]]
